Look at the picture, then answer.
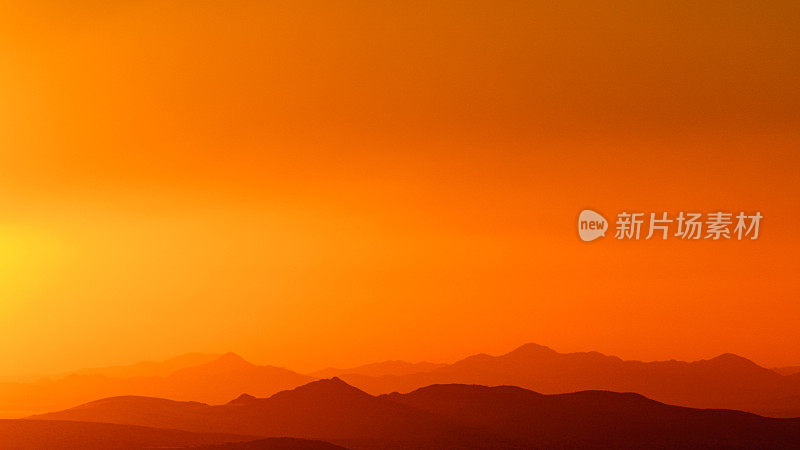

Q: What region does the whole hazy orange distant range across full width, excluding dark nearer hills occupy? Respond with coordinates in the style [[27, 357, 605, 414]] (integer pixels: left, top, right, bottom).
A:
[[0, 344, 800, 418]]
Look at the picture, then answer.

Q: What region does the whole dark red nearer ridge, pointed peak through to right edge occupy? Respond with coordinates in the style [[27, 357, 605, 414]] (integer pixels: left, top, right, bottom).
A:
[[28, 378, 800, 448]]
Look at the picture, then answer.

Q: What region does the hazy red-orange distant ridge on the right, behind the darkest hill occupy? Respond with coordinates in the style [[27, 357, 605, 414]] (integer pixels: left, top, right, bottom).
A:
[[334, 344, 800, 417]]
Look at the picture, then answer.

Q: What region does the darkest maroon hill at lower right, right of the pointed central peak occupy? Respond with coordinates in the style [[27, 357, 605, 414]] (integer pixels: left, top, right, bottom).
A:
[[386, 385, 800, 448]]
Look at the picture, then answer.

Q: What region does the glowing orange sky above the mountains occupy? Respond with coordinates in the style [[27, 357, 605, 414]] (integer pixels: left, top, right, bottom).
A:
[[0, 1, 800, 374]]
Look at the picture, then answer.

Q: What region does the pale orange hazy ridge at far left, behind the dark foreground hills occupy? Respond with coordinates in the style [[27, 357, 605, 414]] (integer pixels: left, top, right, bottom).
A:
[[0, 353, 314, 418]]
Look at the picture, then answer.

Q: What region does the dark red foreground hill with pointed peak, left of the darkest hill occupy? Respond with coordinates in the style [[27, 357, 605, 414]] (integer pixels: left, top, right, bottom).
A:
[[33, 378, 486, 447]]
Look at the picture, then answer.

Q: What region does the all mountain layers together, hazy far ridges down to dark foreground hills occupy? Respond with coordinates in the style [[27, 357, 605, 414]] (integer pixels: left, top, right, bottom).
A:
[[0, 344, 800, 450]]
